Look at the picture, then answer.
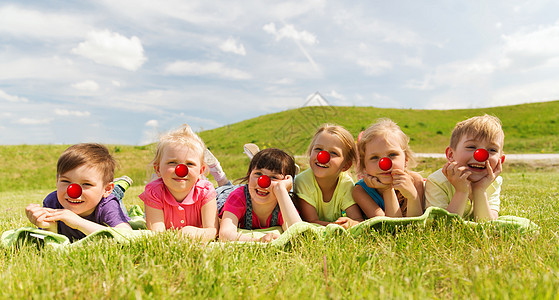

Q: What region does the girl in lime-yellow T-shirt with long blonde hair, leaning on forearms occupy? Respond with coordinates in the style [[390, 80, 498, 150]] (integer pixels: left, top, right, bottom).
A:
[[294, 124, 362, 228]]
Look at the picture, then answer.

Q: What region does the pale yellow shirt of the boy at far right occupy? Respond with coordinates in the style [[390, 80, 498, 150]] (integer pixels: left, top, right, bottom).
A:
[[425, 168, 503, 218]]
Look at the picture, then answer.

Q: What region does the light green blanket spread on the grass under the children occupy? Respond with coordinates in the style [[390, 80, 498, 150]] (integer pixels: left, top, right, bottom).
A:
[[0, 207, 540, 248]]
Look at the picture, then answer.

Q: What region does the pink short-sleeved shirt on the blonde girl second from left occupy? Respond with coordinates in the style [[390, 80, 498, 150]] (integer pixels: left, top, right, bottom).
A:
[[140, 178, 216, 229]]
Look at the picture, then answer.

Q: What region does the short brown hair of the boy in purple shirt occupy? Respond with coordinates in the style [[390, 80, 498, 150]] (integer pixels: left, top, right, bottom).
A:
[[56, 143, 116, 184]]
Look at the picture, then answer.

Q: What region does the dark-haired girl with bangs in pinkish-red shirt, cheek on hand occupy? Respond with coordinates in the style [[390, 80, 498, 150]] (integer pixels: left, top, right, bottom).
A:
[[219, 148, 301, 242]]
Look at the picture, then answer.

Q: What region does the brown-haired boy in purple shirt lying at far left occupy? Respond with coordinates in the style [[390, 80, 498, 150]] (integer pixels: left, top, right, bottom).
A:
[[25, 143, 132, 241]]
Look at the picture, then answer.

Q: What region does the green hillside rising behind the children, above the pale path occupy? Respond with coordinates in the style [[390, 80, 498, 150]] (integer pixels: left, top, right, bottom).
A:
[[200, 101, 559, 154]]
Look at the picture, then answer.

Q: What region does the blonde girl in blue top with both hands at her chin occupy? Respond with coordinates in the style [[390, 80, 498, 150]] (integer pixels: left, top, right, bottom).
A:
[[353, 119, 424, 218]]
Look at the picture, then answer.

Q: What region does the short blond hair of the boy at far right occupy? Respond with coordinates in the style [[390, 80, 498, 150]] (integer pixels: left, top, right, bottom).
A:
[[450, 114, 505, 151]]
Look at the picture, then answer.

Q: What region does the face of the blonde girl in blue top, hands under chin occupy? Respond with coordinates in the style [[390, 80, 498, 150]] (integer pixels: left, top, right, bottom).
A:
[[363, 135, 407, 184]]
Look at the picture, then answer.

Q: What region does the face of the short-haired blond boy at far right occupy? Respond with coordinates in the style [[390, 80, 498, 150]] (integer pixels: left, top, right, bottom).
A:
[[446, 136, 503, 182]]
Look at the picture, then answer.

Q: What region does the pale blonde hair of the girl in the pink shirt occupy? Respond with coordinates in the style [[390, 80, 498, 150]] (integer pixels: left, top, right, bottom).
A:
[[152, 124, 206, 165]]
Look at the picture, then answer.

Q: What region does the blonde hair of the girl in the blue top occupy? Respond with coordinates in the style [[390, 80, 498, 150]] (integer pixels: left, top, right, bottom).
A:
[[357, 118, 416, 172]]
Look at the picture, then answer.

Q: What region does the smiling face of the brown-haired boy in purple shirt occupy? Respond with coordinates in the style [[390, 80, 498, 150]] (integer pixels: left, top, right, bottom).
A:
[[56, 165, 114, 217]]
